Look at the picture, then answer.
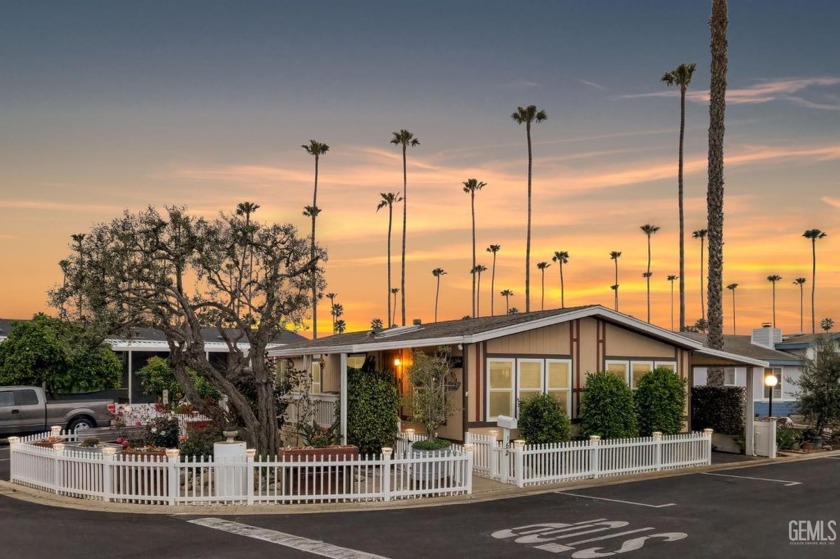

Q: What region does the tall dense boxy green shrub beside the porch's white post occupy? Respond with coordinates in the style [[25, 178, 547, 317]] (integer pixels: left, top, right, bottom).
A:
[[347, 369, 400, 455]]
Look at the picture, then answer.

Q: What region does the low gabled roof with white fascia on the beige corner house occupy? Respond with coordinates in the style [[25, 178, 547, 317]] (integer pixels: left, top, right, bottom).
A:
[[269, 305, 703, 357]]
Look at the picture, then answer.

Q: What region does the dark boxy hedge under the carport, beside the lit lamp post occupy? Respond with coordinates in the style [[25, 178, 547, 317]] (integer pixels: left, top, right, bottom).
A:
[[691, 386, 746, 435]]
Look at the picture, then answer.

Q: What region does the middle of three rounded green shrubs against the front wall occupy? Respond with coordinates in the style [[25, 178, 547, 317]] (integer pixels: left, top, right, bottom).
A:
[[580, 371, 639, 439]]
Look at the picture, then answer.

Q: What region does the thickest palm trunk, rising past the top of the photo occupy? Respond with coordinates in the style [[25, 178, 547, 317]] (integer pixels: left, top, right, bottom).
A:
[[706, 0, 729, 386]]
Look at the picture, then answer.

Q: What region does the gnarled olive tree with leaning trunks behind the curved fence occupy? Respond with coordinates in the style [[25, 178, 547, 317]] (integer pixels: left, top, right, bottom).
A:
[[50, 207, 325, 455]]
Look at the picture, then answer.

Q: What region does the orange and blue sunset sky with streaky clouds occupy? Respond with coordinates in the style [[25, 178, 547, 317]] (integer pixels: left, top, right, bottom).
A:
[[0, 0, 840, 335]]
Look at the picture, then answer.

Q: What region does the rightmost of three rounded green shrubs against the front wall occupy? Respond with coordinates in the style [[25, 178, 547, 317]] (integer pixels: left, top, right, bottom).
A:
[[633, 367, 686, 437]]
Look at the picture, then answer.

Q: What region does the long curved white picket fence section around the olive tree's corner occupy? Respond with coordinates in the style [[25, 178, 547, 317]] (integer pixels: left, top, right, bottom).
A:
[[9, 431, 473, 505]]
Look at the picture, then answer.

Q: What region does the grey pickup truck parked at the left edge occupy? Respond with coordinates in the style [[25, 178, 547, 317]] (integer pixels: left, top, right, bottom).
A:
[[0, 386, 113, 437]]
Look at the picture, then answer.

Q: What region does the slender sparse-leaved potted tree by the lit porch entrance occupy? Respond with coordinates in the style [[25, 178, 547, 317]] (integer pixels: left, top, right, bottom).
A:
[[408, 347, 456, 479]]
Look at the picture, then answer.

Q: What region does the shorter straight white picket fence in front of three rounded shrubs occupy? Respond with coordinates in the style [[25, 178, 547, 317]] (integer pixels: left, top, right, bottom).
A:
[[466, 429, 712, 487]]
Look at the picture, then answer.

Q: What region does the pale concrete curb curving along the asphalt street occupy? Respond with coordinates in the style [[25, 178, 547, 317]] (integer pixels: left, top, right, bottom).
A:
[[0, 450, 840, 516]]
